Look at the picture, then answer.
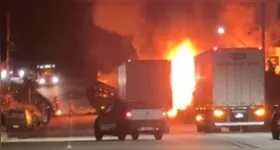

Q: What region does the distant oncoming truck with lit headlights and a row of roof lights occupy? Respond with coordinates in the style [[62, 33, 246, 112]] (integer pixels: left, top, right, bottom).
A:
[[37, 64, 60, 86]]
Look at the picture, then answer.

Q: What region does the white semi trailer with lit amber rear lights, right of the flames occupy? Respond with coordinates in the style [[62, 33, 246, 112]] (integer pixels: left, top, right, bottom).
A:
[[193, 48, 266, 132]]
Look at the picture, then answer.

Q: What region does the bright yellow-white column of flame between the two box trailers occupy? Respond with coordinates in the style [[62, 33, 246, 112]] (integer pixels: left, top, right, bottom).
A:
[[168, 40, 195, 110]]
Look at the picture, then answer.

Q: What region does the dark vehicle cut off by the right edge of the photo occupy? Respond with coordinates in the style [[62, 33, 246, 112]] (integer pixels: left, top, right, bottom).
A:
[[271, 105, 280, 139]]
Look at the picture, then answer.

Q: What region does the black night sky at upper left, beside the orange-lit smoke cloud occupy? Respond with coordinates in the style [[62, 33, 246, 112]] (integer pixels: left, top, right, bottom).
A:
[[1, 0, 137, 76]]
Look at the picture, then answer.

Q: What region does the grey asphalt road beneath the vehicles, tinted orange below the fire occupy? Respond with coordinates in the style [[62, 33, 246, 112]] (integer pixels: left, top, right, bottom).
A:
[[2, 116, 280, 150]]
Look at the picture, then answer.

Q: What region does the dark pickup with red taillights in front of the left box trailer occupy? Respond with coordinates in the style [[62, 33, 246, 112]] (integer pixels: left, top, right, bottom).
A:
[[94, 100, 169, 141]]
